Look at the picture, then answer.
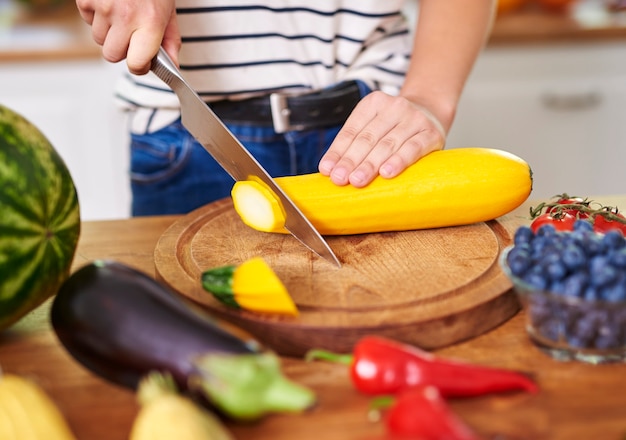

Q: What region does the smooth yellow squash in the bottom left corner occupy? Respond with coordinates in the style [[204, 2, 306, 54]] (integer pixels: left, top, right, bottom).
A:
[[0, 374, 76, 440]]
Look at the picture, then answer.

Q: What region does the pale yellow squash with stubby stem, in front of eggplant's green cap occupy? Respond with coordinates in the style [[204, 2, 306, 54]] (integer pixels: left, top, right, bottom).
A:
[[129, 372, 234, 440]]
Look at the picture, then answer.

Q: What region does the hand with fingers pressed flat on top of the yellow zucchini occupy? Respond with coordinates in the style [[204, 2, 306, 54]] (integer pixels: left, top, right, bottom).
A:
[[319, 91, 446, 187]]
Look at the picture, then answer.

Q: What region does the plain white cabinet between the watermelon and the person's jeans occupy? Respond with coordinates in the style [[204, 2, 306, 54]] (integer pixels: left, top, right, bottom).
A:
[[0, 58, 130, 220]]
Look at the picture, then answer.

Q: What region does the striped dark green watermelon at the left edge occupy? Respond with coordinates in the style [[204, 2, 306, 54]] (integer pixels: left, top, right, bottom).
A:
[[0, 105, 80, 330]]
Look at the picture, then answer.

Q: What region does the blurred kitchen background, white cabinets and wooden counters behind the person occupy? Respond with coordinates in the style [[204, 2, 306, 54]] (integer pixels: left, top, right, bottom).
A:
[[0, 0, 626, 220]]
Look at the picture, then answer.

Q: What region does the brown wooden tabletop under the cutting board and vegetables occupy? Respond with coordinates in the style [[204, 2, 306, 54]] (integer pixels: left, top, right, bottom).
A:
[[0, 197, 626, 440]]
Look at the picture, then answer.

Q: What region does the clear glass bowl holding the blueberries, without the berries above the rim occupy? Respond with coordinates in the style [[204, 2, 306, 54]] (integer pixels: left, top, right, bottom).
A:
[[500, 246, 626, 364]]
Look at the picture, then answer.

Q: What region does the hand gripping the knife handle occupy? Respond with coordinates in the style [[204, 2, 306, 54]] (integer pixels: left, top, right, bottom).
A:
[[76, 0, 181, 75]]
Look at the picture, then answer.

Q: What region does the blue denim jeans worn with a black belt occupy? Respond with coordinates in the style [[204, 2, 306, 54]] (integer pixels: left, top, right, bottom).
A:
[[130, 83, 369, 216]]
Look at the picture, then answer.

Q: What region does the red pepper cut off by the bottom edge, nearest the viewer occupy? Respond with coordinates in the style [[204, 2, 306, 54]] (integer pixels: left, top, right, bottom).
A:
[[384, 386, 478, 440]]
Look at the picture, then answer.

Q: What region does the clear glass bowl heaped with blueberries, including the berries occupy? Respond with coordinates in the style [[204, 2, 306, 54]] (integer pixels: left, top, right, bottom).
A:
[[499, 219, 626, 364]]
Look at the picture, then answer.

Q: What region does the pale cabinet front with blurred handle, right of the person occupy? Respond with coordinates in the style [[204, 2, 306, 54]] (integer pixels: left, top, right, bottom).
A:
[[448, 42, 626, 198]]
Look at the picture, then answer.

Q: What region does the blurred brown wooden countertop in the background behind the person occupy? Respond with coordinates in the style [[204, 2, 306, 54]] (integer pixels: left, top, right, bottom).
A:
[[0, 0, 626, 63]]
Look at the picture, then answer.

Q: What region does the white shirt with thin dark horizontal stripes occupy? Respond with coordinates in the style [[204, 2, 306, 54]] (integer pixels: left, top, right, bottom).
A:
[[116, 0, 411, 132]]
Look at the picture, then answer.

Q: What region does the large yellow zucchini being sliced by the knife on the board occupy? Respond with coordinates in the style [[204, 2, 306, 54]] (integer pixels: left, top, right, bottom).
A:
[[231, 147, 532, 235]]
